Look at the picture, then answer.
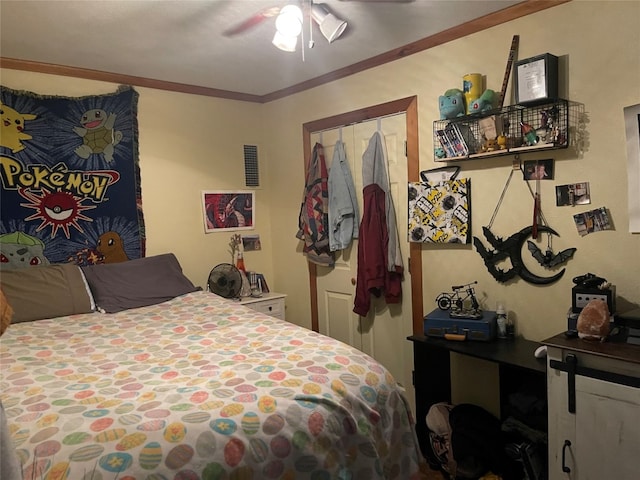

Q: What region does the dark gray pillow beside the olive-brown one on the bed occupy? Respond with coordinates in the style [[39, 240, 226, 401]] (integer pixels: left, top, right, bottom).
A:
[[80, 253, 200, 313]]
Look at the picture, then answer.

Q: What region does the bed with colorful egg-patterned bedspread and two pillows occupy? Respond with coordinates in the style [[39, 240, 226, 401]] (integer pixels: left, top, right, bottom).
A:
[[0, 254, 421, 480]]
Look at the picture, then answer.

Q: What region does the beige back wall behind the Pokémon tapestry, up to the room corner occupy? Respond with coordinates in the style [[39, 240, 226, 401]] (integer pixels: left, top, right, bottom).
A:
[[0, 69, 273, 287]]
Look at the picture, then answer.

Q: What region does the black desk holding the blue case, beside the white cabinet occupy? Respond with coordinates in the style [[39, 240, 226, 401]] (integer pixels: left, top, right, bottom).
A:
[[407, 335, 547, 458]]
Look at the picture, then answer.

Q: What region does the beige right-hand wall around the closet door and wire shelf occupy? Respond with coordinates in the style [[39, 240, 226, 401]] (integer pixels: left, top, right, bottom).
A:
[[265, 1, 640, 340]]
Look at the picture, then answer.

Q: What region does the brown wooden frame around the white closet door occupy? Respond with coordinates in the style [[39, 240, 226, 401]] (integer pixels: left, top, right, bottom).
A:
[[302, 95, 424, 335]]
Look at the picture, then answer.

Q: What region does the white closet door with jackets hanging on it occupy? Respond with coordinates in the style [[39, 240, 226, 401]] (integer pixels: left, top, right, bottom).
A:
[[311, 114, 414, 410]]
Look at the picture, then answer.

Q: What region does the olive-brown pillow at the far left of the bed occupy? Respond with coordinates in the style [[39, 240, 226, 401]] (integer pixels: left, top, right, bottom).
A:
[[0, 263, 93, 323]]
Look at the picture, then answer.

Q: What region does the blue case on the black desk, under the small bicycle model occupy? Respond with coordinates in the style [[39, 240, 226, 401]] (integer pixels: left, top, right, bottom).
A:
[[424, 308, 497, 342]]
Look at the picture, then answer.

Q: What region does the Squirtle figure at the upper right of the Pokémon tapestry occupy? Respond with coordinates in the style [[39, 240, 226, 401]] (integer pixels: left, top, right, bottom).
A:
[[73, 108, 122, 163]]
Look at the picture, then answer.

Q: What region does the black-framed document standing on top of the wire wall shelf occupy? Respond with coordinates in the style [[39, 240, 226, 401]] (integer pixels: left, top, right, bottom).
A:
[[514, 53, 558, 104]]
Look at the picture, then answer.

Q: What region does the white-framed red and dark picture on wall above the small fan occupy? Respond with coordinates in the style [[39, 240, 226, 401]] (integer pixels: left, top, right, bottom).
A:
[[202, 190, 256, 233]]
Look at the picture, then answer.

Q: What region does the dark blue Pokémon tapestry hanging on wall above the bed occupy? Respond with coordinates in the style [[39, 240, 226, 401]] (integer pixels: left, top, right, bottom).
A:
[[0, 86, 145, 269]]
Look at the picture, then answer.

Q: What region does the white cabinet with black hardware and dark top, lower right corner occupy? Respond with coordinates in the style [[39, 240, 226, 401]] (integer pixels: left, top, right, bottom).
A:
[[543, 335, 640, 480]]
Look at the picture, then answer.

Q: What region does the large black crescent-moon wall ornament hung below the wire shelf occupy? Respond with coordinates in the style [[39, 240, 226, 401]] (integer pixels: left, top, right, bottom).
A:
[[473, 225, 575, 285]]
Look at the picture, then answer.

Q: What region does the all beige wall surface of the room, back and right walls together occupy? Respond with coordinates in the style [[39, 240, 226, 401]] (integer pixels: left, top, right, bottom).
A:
[[1, 0, 640, 412]]
